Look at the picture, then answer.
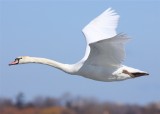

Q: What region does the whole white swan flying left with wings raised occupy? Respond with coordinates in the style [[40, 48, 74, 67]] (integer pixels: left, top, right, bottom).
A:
[[9, 8, 149, 82]]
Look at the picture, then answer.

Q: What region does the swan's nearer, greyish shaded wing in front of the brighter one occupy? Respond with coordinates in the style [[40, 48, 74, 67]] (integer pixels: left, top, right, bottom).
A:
[[85, 34, 128, 68]]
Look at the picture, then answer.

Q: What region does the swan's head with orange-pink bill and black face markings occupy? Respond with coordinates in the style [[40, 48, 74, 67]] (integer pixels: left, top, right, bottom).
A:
[[9, 56, 30, 65]]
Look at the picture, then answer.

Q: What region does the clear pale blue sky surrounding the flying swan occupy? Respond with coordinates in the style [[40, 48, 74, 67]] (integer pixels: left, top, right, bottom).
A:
[[0, 0, 160, 104]]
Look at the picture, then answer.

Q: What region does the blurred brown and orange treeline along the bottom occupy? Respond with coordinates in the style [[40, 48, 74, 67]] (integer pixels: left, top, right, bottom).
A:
[[0, 93, 160, 114]]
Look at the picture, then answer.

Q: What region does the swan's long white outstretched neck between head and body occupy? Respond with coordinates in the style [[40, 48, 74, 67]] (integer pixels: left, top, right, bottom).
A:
[[26, 57, 75, 74]]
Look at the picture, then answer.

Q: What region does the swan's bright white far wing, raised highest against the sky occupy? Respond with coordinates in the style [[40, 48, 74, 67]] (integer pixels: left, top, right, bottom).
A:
[[81, 8, 119, 61]]
